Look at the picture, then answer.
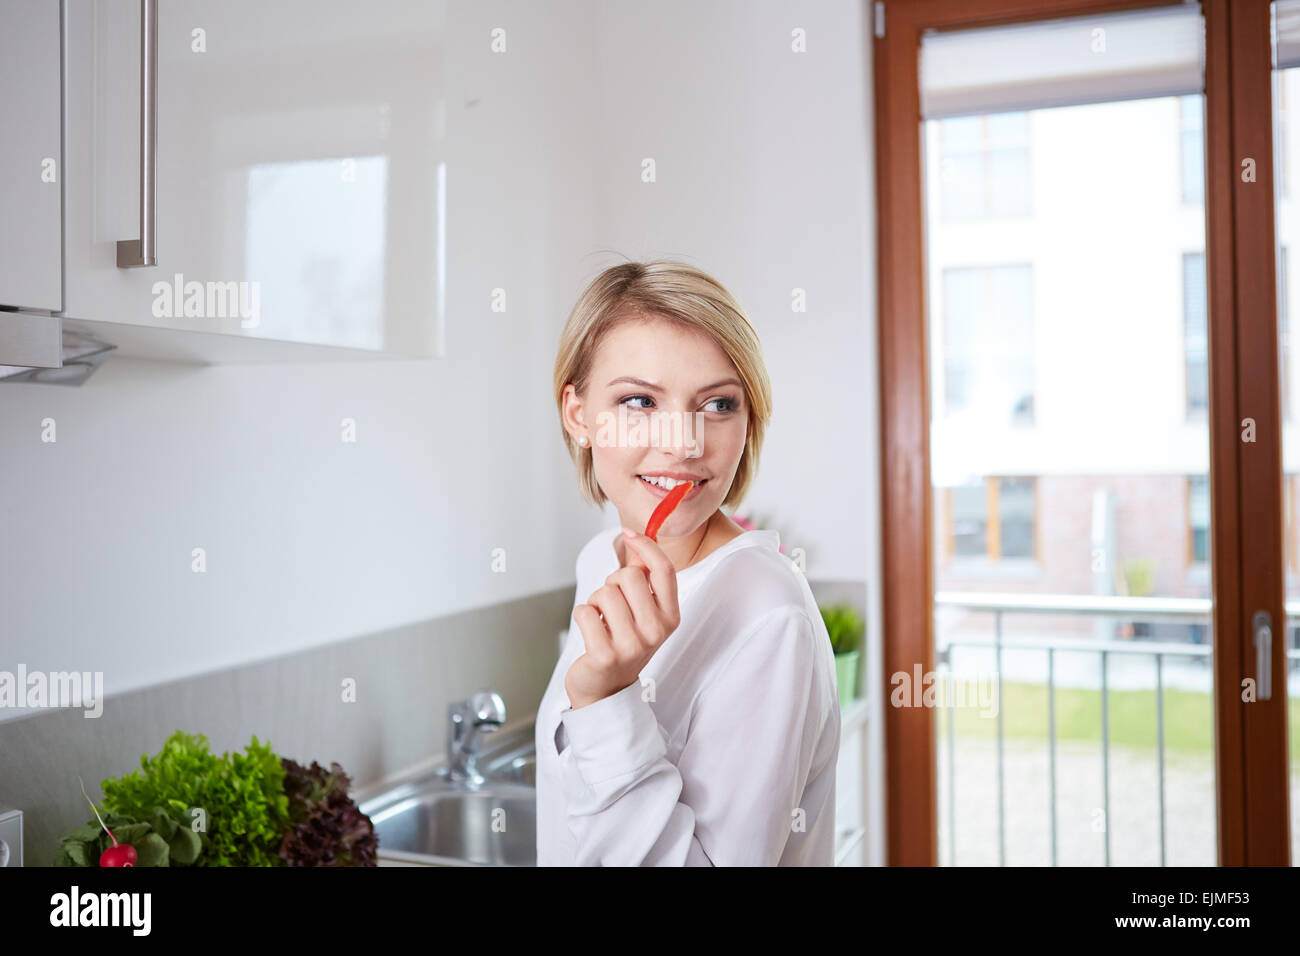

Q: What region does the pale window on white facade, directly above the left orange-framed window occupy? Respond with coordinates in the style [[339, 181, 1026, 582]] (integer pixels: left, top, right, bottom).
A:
[[943, 265, 1035, 425]]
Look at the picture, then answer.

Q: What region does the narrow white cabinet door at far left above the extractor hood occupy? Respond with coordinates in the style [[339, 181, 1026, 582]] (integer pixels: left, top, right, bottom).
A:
[[0, 0, 64, 314]]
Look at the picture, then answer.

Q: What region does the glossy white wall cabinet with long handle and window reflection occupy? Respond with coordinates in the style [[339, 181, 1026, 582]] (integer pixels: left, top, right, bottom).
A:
[[64, 0, 447, 362]]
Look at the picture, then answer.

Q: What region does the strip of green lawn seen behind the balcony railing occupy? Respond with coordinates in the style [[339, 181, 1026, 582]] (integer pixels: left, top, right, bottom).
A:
[[936, 680, 1300, 761]]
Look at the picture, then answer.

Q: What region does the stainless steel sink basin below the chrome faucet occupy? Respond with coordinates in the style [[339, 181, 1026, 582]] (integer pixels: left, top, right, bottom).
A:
[[360, 702, 537, 866]]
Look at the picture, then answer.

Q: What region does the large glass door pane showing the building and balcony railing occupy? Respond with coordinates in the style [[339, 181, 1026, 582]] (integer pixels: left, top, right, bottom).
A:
[[919, 13, 1216, 866]]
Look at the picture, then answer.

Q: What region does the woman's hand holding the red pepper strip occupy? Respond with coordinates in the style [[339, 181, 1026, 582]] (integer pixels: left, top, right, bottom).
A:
[[564, 533, 681, 710]]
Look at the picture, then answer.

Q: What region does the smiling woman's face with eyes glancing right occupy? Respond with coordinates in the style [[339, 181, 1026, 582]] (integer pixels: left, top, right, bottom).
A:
[[566, 316, 749, 537]]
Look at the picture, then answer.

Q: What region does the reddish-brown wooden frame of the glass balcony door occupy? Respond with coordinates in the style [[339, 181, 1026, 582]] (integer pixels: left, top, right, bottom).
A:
[[872, 0, 1290, 866]]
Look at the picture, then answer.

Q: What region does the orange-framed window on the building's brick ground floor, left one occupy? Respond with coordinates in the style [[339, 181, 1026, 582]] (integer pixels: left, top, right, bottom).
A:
[[945, 476, 1037, 561]]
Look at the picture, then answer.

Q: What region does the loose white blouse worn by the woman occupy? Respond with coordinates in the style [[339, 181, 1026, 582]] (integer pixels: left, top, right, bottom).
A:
[[536, 527, 840, 866]]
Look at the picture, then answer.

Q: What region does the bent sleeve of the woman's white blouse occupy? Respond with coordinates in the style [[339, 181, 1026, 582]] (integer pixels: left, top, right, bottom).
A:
[[559, 606, 833, 866]]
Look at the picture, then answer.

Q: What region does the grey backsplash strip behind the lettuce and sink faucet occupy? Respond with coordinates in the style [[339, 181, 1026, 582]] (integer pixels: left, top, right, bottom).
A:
[[0, 587, 573, 866]]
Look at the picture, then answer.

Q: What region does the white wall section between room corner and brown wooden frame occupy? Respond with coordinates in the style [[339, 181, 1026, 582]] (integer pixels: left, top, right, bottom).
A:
[[592, 0, 876, 578]]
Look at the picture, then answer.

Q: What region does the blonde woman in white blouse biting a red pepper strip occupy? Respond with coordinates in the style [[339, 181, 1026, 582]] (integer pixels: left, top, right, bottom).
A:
[[537, 260, 840, 866]]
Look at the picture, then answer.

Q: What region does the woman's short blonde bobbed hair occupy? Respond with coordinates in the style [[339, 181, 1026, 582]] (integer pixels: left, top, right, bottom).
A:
[[555, 259, 772, 506]]
